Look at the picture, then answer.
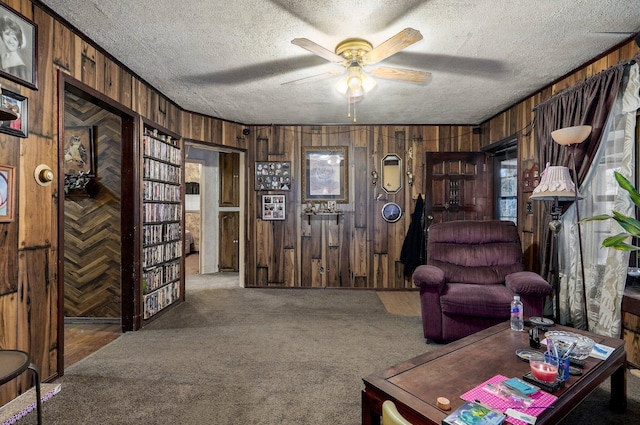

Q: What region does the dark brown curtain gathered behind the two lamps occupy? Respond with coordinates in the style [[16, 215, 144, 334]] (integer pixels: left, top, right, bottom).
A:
[[533, 65, 624, 312]]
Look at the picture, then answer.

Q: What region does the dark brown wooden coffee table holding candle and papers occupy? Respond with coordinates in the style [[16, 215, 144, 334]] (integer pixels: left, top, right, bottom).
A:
[[362, 322, 627, 425]]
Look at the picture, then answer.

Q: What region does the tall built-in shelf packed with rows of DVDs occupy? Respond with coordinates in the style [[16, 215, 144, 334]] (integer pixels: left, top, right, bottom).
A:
[[141, 125, 184, 320]]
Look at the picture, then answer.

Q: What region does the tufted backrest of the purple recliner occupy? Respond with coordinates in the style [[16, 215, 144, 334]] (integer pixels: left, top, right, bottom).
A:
[[427, 220, 524, 285]]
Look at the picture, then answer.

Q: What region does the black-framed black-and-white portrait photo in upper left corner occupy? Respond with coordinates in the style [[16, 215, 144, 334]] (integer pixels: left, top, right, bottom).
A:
[[0, 3, 38, 90]]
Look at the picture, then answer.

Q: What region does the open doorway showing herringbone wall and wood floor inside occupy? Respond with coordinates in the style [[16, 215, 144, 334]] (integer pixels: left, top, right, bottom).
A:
[[57, 74, 137, 371]]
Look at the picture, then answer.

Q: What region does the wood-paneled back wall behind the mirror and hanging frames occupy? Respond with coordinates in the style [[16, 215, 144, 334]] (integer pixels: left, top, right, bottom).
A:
[[246, 126, 479, 289]]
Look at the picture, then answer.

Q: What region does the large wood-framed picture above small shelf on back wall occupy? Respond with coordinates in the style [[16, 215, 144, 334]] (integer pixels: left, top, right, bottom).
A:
[[301, 146, 349, 203]]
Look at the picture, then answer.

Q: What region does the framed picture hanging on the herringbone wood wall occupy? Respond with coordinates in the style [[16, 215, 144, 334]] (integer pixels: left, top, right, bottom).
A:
[[64, 127, 98, 177]]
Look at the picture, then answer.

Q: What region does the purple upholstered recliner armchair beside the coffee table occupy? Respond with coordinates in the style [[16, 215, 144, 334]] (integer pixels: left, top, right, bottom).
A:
[[413, 220, 552, 342]]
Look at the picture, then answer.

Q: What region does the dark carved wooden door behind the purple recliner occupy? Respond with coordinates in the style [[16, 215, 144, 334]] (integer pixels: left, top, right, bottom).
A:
[[424, 152, 493, 224]]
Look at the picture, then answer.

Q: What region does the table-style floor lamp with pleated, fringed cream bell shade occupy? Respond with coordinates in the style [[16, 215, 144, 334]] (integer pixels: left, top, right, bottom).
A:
[[530, 165, 581, 322]]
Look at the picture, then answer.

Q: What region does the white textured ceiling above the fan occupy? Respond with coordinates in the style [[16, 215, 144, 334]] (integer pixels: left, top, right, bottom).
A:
[[42, 0, 640, 124]]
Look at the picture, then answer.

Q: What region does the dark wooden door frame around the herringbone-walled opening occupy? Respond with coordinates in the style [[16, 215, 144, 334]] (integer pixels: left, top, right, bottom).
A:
[[56, 70, 141, 376]]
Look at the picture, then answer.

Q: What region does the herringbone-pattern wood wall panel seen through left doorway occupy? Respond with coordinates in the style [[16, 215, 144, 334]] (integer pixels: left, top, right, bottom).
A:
[[64, 93, 122, 318]]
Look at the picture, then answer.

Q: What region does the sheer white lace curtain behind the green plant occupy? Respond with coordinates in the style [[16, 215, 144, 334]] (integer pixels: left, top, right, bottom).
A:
[[560, 64, 640, 338]]
